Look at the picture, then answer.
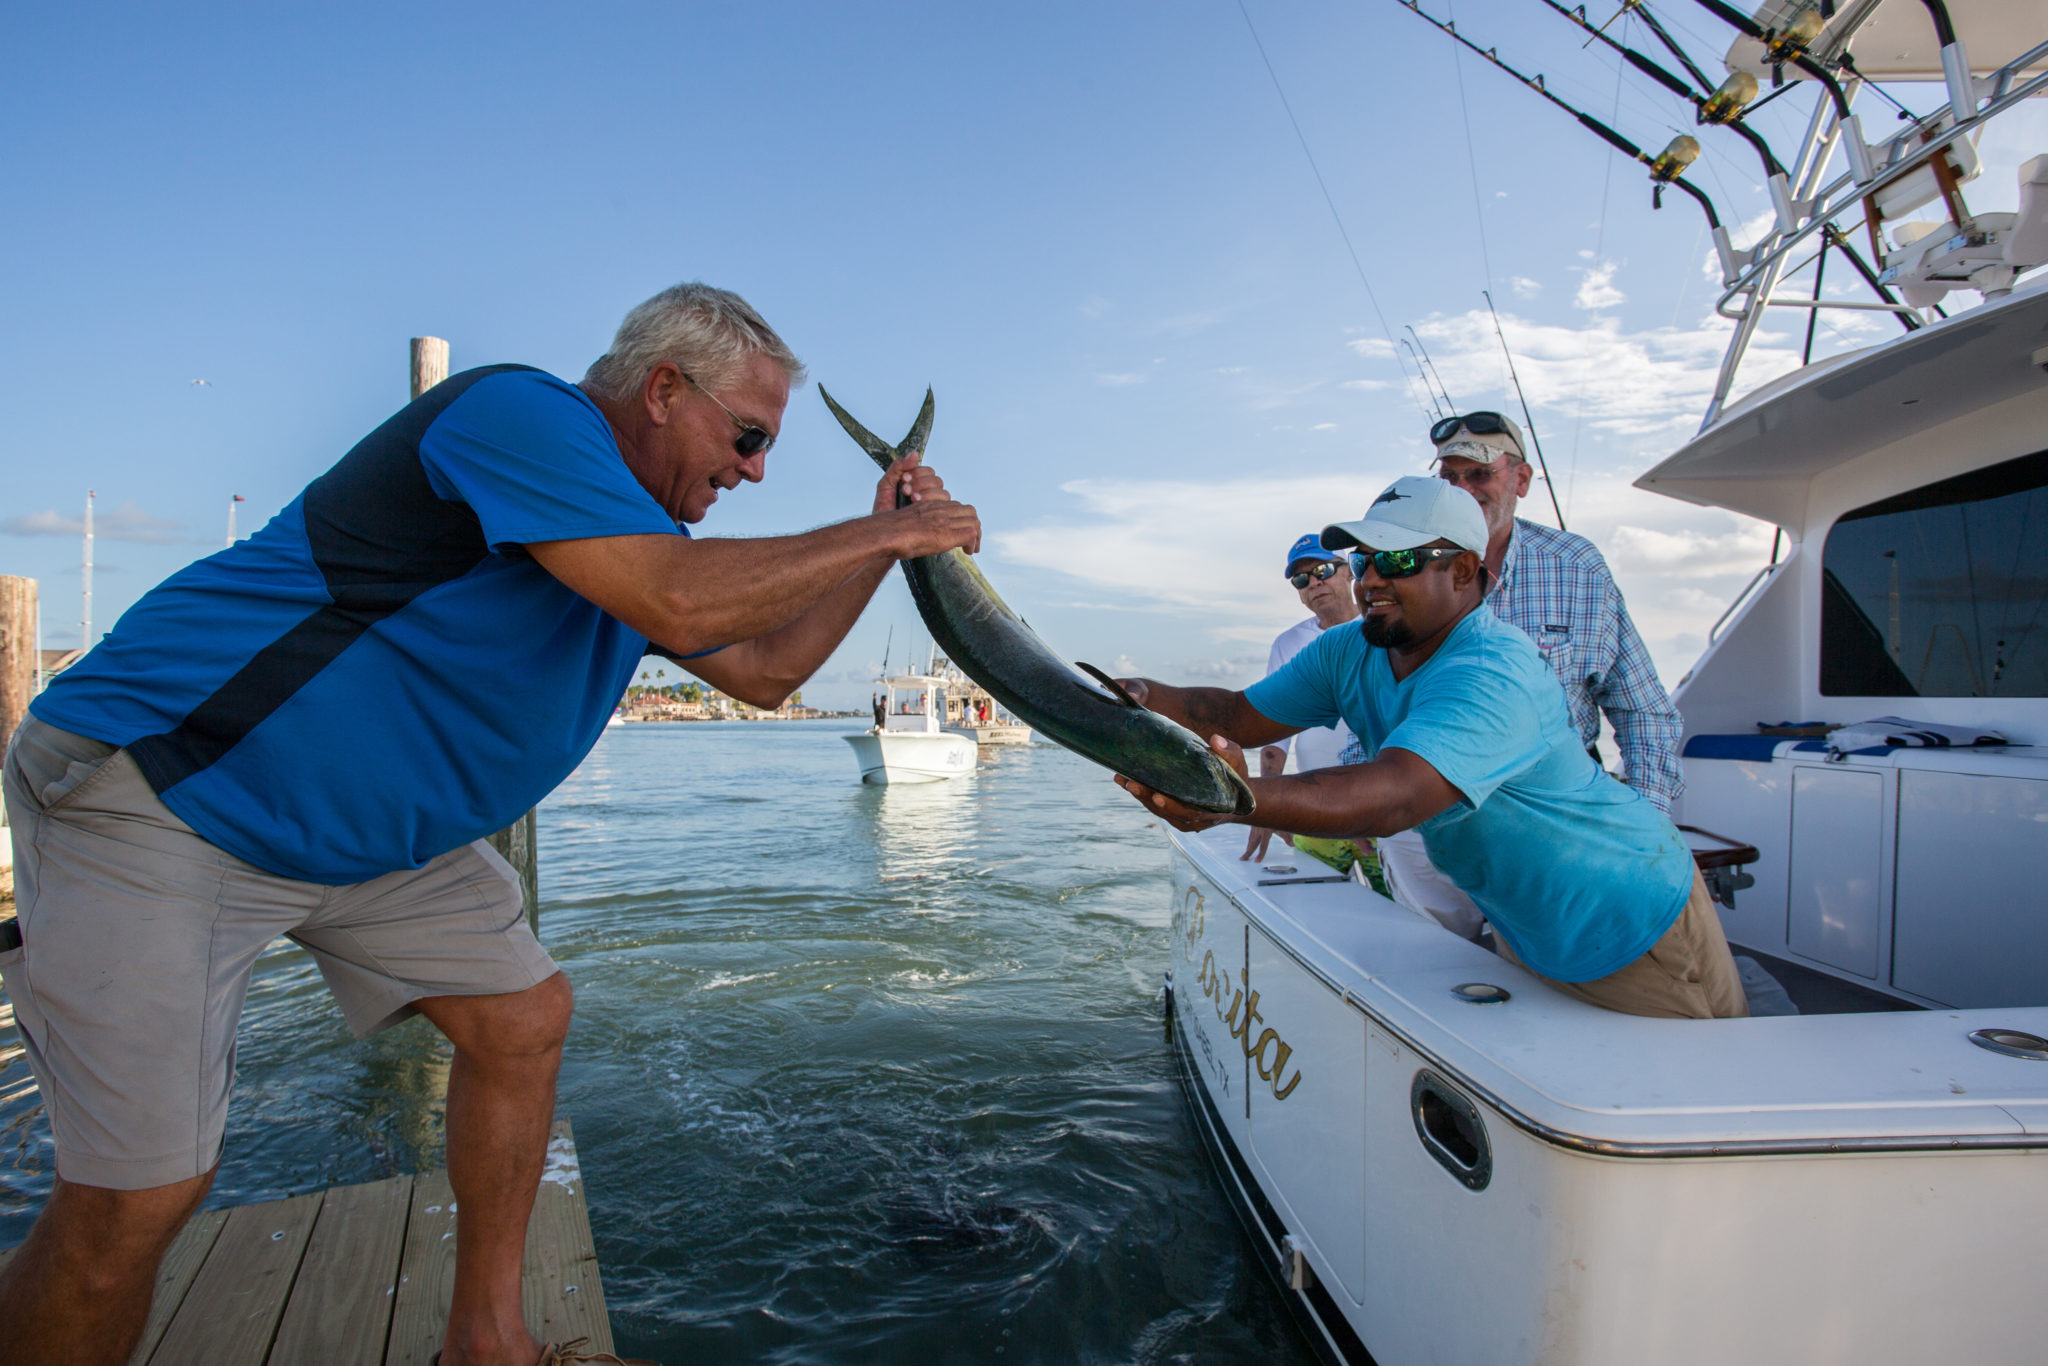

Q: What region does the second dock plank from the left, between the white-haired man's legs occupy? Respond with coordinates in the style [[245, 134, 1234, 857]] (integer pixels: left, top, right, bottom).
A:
[[150, 1194, 319, 1366]]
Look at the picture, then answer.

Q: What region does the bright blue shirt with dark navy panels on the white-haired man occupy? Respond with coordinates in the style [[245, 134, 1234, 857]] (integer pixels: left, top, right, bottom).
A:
[[31, 367, 682, 885]]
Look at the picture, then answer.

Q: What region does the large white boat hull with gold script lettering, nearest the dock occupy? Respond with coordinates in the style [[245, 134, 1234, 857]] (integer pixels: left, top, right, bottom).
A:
[[1169, 827, 2048, 1366]]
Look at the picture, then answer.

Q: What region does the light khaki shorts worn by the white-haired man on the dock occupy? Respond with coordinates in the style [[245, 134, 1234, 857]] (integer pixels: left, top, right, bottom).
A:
[[0, 717, 555, 1190]]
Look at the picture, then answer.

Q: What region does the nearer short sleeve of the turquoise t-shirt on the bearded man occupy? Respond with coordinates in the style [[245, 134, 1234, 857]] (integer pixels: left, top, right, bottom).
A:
[[1380, 653, 1548, 811]]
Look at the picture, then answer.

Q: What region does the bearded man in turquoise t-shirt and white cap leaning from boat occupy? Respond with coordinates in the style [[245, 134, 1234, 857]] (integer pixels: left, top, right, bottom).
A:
[[1118, 477, 1749, 1018]]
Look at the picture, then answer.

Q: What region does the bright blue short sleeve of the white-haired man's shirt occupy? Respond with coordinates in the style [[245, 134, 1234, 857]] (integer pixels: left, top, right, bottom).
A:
[[420, 371, 676, 551]]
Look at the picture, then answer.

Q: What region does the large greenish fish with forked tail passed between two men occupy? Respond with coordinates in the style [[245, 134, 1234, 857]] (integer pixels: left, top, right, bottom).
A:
[[817, 385, 1253, 815]]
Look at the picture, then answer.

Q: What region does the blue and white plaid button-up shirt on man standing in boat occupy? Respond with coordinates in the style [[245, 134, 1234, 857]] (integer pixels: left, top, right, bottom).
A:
[[1343, 518, 1686, 813]]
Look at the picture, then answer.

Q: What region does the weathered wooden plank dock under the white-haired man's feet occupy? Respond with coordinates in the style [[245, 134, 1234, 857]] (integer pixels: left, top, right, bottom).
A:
[[0, 1120, 612, 1366]]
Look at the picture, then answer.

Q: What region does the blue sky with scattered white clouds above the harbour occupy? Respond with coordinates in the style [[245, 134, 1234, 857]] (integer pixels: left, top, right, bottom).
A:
[[0, 0, 2048, 705]]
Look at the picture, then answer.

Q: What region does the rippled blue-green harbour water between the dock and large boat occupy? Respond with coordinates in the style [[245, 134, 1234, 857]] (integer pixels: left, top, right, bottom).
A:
[[0, 721, 1311, 1364]]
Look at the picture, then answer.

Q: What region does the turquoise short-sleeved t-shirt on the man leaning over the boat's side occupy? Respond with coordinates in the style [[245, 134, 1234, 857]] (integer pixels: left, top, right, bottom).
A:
[[1245, 610, 1694, 981]]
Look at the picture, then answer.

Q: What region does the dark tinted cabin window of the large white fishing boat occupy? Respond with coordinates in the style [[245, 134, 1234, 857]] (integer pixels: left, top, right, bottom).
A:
[[1821, 451, 2048, 696]]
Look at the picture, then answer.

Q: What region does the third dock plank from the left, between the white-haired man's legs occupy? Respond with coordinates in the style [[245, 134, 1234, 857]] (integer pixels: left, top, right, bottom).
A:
[[270, 1176, 414, 1366]]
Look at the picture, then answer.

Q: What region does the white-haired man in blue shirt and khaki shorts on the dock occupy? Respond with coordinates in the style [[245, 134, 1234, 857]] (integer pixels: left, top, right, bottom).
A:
[[0, 285, 981, 1366]]
